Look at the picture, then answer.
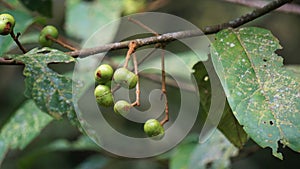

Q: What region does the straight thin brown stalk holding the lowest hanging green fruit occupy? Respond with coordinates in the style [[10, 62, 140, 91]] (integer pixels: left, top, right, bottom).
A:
[[160, 48, 169, 126]]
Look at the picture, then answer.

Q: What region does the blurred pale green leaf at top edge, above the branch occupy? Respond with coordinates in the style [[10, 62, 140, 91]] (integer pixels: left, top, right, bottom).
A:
[[66, 0, 122, 41]]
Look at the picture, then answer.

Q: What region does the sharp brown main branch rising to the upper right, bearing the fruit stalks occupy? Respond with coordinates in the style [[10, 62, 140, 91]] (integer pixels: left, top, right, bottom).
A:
[[68, 0, 292, 57]]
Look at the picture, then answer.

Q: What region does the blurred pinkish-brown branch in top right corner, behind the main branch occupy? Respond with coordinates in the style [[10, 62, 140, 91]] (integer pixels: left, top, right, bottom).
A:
[[222, 0, 300, 15]]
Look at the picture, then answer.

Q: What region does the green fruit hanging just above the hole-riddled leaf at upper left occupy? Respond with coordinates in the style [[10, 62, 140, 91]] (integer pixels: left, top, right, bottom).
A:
[[39, 25, 58, 47]]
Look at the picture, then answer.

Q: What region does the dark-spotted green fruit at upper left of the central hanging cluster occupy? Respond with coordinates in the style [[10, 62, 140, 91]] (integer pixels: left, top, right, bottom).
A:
[[94, 64, 114, 84]]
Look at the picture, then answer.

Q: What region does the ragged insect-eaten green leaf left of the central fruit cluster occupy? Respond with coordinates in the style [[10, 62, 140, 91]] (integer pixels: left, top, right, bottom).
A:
[[9, 48, 75, 119]]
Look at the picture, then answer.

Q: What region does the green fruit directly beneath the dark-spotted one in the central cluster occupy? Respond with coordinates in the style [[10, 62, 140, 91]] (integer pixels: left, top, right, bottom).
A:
[[94, 85, 114, 107]]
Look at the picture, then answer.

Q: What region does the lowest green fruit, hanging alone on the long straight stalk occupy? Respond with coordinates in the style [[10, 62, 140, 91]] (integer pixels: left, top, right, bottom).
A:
[[144, 119, 165, 139]]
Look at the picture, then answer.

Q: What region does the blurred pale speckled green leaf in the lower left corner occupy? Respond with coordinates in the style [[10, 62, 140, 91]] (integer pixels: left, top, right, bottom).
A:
[[0, 100, 52, 164]]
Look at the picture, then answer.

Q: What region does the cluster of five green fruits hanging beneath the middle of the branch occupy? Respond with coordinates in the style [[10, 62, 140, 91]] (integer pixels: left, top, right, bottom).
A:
[[94, 64, 164, 138]]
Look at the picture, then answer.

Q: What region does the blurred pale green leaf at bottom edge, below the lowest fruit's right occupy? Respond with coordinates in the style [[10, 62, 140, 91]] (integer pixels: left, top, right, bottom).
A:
[[170, 130, 238, 169]]
